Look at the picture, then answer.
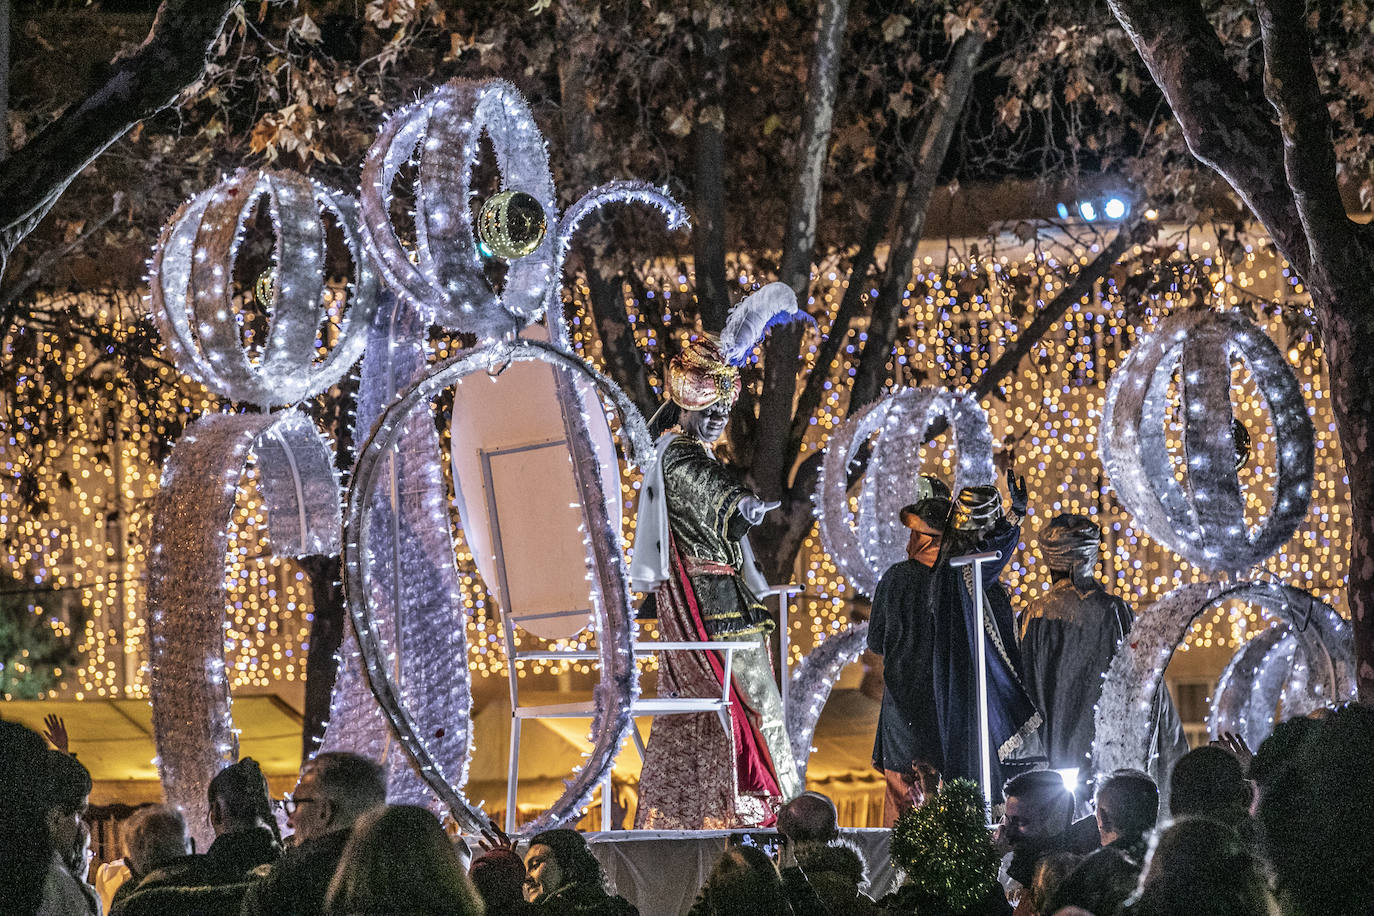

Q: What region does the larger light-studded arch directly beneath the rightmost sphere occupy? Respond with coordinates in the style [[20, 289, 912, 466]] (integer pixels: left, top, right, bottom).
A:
[[1092, 581, 1355, 773]]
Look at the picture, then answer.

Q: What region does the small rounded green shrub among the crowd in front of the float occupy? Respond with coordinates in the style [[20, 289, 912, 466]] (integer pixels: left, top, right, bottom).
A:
[[890, 779, 999, 916]]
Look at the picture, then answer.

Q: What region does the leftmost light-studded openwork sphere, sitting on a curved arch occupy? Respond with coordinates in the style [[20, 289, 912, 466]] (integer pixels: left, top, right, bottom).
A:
[[148, 169, 378, 408]]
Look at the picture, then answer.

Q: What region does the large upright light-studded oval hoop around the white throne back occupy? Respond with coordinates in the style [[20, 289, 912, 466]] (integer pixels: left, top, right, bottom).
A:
[[344, 339, 654, 831]]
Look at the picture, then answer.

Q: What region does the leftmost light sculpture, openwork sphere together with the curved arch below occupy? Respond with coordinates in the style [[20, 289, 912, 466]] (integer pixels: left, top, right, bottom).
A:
[[148, 170, 378, 842]]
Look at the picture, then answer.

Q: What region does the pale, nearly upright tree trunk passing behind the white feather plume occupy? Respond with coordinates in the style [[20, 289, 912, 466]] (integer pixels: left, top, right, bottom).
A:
[[750, 0, 849, 499]]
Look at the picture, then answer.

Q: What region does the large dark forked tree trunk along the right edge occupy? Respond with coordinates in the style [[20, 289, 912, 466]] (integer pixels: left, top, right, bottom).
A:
[[1110, 0, 1374, 702]]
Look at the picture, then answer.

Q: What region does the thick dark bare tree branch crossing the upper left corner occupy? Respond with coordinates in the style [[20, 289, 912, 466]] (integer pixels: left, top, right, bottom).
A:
[[0, 0, 239, 253]]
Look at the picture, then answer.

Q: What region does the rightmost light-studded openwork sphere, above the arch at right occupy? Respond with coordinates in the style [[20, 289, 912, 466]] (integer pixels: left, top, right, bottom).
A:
[[1099, 309, 1314, 573]]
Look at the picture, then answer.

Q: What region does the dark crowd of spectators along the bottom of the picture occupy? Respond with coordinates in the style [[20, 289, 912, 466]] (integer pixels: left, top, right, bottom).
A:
[[0, 705, 1374, 916]]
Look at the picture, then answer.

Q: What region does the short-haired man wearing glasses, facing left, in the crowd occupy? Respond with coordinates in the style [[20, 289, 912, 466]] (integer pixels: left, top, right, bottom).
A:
[[240, 753, 386, 916]]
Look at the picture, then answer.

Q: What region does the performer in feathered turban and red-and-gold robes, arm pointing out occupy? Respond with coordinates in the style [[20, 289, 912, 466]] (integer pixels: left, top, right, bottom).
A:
[[629, 283, 805, 829]]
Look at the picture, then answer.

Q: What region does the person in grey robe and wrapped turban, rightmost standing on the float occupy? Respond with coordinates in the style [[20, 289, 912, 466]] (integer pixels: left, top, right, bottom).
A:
[[1021, 512, 1189, 796]]
